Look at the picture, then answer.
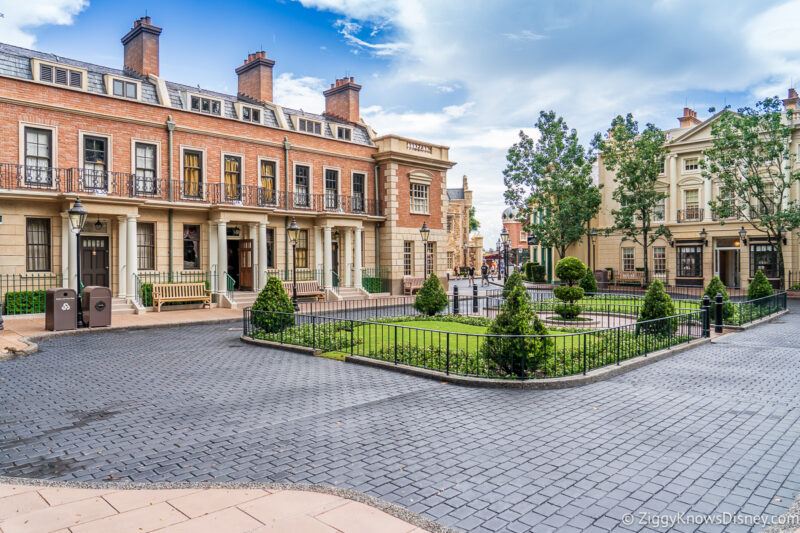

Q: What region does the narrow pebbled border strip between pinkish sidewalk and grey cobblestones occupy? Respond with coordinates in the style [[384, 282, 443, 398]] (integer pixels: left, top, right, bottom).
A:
[[0, 475, 458, 533]]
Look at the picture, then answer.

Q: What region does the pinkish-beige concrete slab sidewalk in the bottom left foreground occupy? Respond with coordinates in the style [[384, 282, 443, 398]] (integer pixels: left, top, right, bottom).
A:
[[0, 485, 424, 533]]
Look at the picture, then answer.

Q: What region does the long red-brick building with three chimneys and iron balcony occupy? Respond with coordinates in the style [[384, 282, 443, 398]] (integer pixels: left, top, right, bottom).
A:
[[0, 17, 454, 305]]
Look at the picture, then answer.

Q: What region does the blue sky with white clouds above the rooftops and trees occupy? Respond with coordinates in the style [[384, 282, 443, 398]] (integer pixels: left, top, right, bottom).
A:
[[0, 0, 800, 243]]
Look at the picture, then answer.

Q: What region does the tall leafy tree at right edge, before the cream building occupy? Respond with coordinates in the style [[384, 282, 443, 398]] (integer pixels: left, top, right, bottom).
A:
[[700, 97, 800, 286]]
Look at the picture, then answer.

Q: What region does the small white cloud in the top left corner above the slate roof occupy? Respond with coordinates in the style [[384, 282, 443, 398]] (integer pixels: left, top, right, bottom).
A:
[[0, 0, 89, 48]]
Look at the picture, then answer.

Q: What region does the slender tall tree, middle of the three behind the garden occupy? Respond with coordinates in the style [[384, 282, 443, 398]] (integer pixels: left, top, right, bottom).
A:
[[592, 113, 670, 283]]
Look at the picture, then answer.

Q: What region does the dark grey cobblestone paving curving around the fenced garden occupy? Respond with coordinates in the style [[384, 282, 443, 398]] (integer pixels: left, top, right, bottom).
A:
[[0, 313, 800, 532]]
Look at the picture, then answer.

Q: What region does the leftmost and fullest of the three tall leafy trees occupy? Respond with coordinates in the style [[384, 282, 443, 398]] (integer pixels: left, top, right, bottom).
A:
[[503, 111, 602, 258]]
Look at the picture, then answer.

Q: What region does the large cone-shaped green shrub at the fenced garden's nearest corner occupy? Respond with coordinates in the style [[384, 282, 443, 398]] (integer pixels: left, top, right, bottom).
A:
[[481, 285, 552, 377]]
